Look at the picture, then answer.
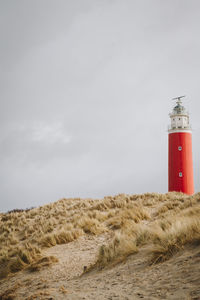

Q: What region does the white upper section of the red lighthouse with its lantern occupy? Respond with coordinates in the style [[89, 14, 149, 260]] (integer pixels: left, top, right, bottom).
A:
[[168, 96, 191, 133]]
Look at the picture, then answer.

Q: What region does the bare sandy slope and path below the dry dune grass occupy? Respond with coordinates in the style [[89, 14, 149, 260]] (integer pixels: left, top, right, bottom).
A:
[[0, 234, 200, 300]]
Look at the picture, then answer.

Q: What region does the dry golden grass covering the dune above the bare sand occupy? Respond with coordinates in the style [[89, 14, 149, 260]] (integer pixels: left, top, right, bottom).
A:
[[0, 193, 200, 278]]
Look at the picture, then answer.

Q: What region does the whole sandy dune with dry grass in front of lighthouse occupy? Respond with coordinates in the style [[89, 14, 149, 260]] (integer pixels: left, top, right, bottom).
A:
[[0, 193, 200, 300]]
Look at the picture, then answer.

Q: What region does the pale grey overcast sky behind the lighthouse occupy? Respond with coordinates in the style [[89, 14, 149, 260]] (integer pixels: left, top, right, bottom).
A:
[[0, 0, 200, 211]]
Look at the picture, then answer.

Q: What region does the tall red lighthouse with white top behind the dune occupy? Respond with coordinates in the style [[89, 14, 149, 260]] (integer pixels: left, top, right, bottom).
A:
[[168, 96, 194, 195]]
